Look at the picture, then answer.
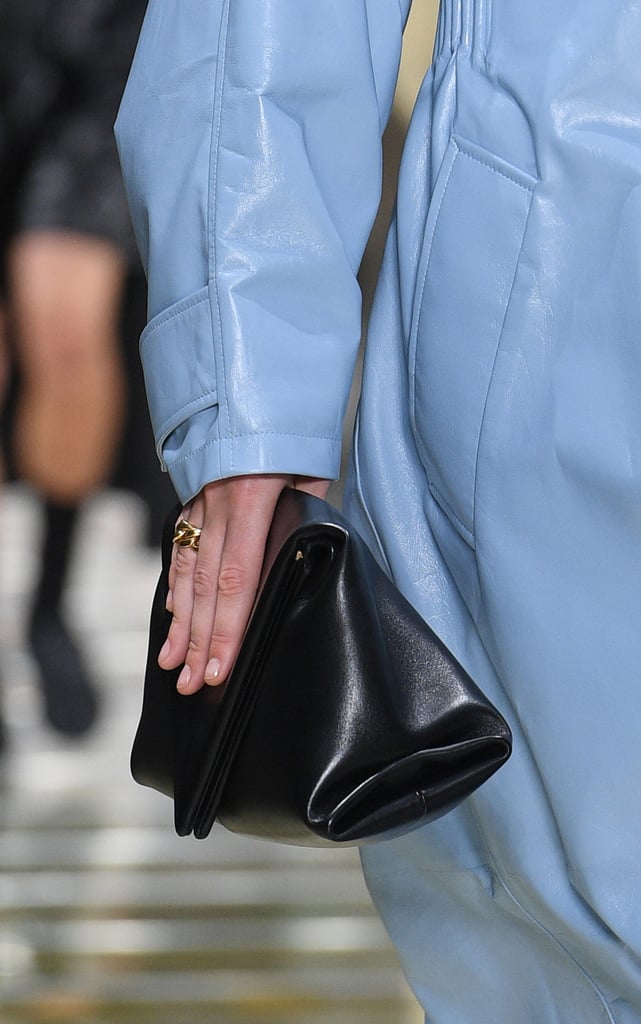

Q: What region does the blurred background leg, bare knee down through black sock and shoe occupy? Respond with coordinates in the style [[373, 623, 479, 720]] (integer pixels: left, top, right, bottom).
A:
[[9, 231, 125, 735]]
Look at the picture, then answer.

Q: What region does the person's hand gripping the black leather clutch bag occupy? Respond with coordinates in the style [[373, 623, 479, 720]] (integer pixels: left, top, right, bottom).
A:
[[158, 475, 330, 693]]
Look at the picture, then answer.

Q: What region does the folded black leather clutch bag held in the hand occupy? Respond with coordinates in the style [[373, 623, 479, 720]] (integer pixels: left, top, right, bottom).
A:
[[131, 489, 511, 846]]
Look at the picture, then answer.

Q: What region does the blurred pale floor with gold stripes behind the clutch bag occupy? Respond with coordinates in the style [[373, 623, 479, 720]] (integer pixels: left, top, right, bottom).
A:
[[0, 487, 422, 1024]]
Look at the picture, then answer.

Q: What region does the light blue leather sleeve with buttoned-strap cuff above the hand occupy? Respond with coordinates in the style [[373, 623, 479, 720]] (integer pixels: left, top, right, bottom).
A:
[[117, 0, 403, 501]]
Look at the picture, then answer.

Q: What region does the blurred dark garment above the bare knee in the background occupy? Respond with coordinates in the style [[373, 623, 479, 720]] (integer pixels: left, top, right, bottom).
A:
[[0, 0, 145, 276]]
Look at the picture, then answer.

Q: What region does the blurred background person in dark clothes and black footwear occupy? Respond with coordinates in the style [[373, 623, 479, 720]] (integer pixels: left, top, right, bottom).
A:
[[0, 0, 145, 749]]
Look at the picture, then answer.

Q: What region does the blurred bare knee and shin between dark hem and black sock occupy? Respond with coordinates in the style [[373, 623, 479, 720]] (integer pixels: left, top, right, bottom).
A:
[[9, 231, 125, 504]]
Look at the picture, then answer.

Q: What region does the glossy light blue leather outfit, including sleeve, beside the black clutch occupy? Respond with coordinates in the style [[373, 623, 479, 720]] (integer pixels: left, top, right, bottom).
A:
[[118, 0, 641, 1024]]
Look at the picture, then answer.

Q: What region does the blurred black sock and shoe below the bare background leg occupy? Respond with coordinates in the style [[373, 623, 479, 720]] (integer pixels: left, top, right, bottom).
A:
[[28, 502, 98, 736]]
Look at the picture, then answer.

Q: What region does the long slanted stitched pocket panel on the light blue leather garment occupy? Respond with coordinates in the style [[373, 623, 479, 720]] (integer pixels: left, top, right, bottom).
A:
[[410, 137, 537, 546]]
